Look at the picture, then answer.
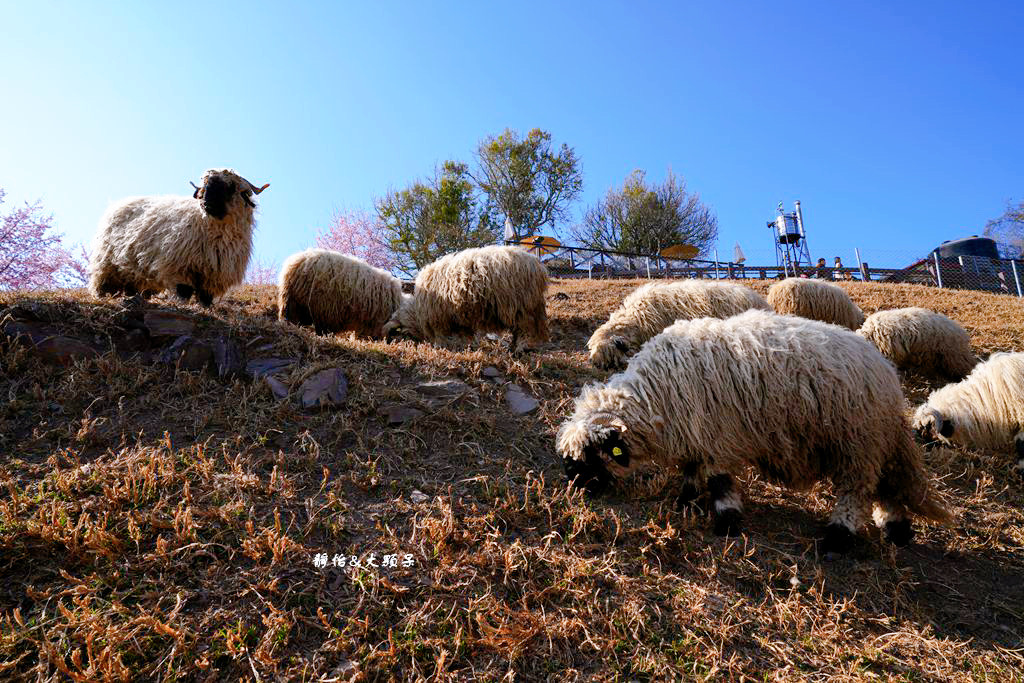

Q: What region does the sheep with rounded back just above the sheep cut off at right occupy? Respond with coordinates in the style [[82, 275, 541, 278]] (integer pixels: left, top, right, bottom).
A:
[[857, 308, 978, 380]]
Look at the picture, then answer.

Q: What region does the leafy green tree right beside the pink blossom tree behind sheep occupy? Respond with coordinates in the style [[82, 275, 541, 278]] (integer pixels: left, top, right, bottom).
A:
[[375, 161, 499, 275]]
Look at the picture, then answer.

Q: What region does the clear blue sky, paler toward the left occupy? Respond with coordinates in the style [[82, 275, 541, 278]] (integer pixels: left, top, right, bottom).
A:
[[0, 1, 1024, 265]]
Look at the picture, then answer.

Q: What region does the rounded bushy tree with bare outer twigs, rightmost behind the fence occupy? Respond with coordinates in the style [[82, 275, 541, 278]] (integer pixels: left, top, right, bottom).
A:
[[570, 169, 718, 254]]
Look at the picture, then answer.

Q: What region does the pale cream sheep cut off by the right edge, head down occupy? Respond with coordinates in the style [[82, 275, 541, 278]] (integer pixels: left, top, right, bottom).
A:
[[913, 353, 1024, 476]]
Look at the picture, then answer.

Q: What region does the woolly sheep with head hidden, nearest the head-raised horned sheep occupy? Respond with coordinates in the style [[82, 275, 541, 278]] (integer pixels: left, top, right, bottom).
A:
[[278, 249, 402, 338]]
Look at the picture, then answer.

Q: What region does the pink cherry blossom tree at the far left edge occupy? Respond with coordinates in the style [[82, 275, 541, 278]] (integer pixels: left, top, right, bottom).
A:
[[0, 187, 89, 290]]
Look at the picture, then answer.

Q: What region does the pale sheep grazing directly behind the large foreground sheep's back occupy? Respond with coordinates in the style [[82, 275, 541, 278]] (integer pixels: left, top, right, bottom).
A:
[[587, 280, 771, 370]]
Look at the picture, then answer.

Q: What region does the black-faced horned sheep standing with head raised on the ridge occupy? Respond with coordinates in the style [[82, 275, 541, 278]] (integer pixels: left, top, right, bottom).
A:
[[89, 169, 268, 306]]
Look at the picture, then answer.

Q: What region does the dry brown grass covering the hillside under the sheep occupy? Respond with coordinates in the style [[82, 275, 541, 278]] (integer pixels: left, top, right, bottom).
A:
[[0, 282, 1024, 681]]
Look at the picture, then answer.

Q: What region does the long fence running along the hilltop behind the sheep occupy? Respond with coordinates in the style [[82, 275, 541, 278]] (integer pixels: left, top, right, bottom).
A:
[[506, 240, 1024, 296]]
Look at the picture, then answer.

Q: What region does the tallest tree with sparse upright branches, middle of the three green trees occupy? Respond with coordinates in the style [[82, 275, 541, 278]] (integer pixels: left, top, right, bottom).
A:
[[472, 128, 583, 239]]
